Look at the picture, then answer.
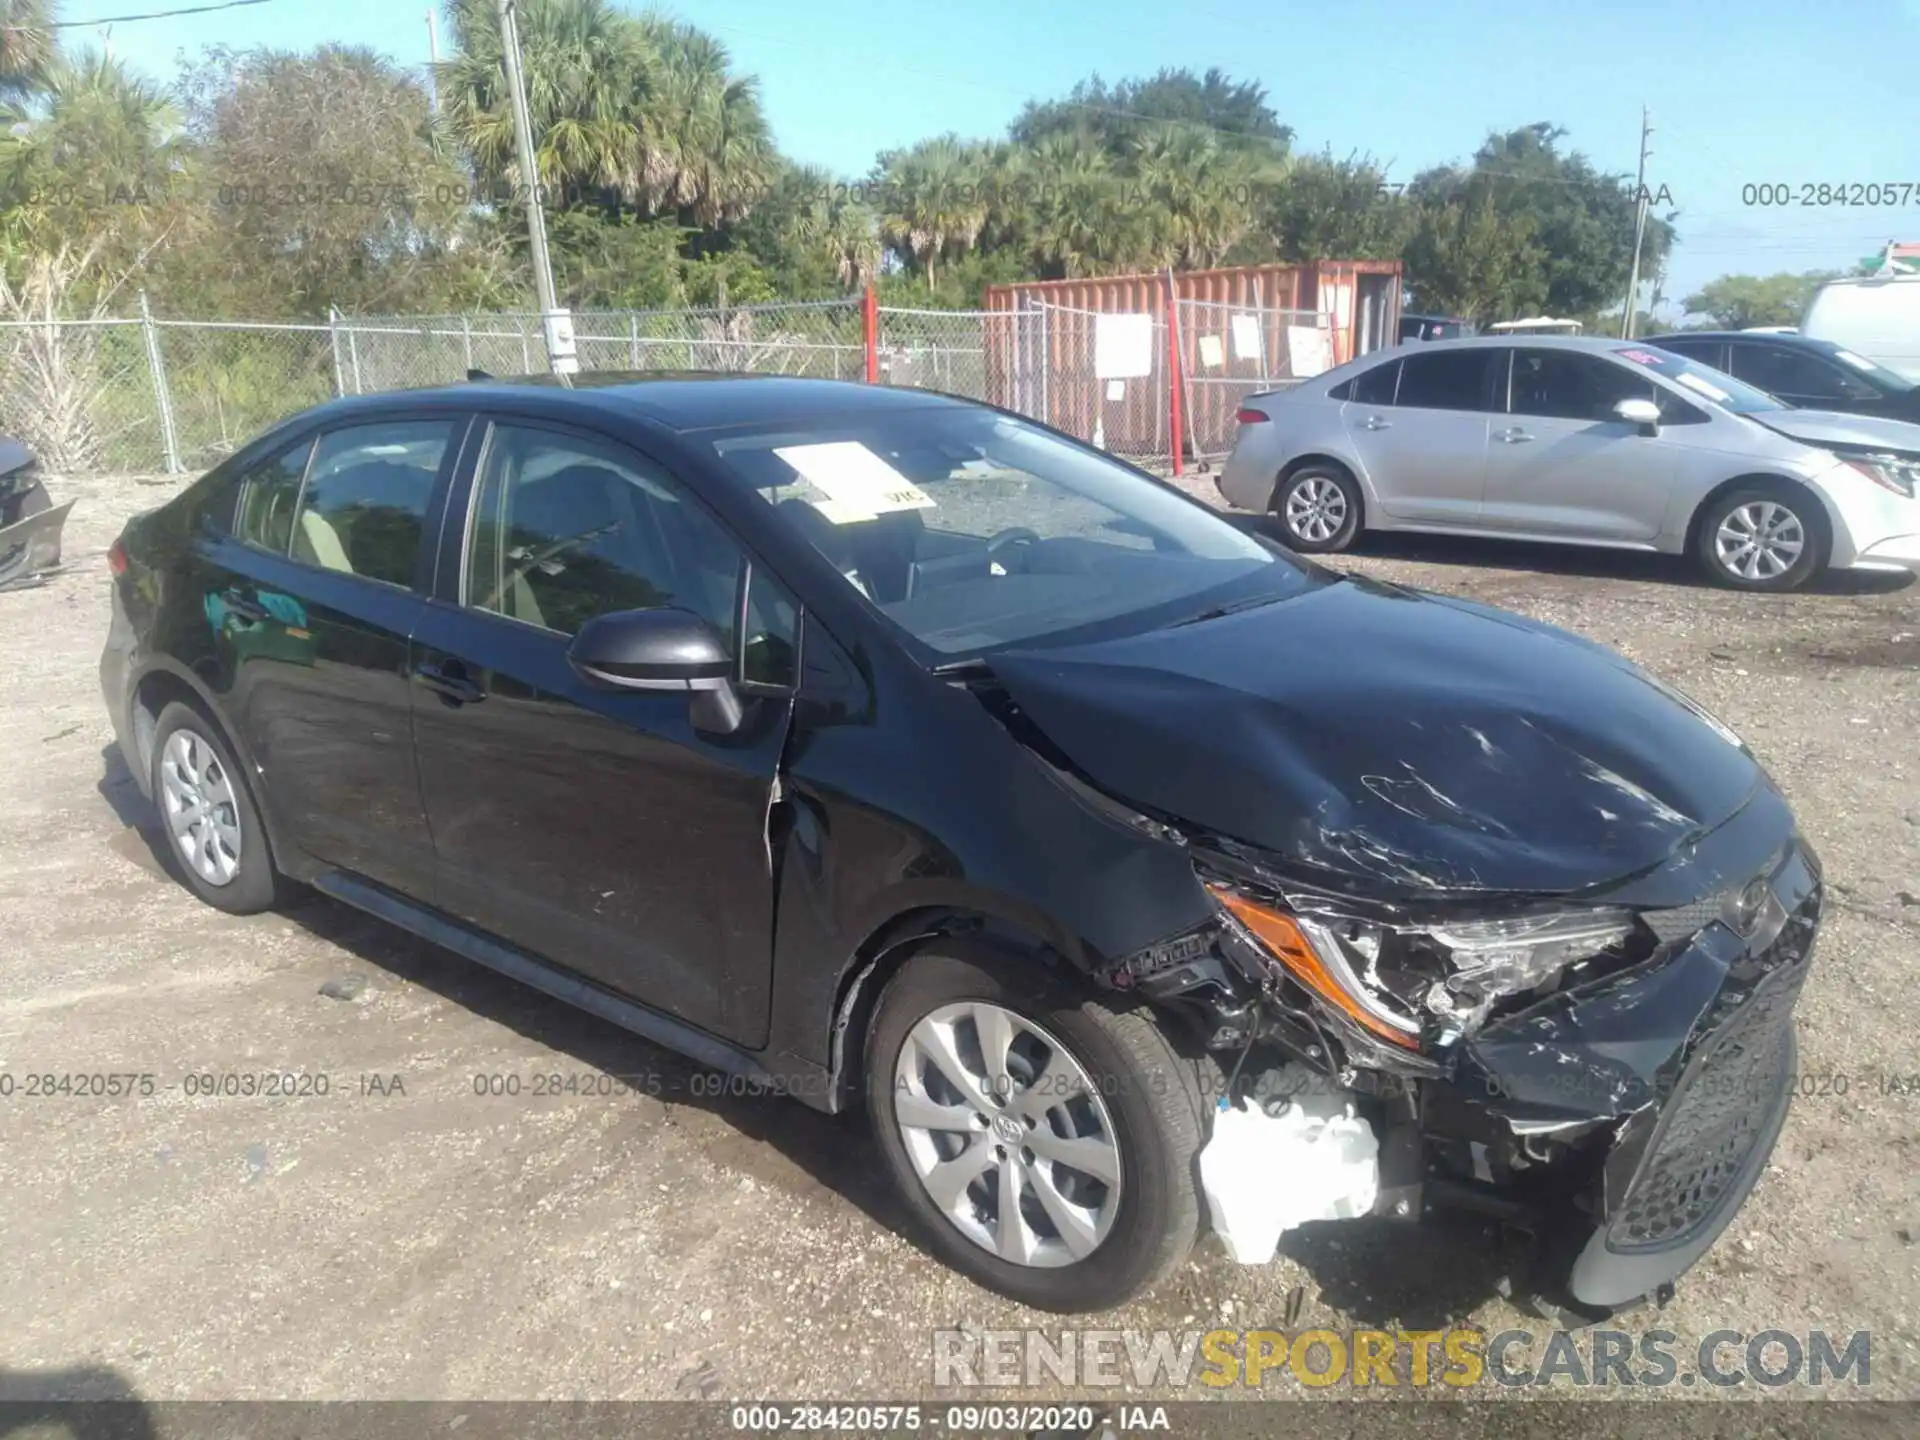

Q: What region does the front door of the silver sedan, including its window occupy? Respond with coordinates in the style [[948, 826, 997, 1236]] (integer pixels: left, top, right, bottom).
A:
[[1480, 346, 1674, 541]]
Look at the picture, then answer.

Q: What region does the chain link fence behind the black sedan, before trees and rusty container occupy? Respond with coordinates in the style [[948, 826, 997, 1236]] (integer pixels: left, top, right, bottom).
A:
[[0, 300, 1244, 472]]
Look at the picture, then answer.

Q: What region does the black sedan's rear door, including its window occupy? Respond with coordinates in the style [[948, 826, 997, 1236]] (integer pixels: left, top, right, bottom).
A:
[[210, 415, 467, 899]]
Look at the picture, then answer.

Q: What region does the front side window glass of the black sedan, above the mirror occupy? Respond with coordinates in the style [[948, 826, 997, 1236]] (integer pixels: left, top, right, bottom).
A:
[[465, 424, 799, 685]]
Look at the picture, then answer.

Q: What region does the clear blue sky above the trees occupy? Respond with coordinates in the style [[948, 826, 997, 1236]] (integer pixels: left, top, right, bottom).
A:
[[74, 0, 1920, 312]]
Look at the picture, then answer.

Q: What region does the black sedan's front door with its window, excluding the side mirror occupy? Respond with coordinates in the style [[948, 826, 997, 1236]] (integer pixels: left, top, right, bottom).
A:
[[415, 422, 799, 1046]]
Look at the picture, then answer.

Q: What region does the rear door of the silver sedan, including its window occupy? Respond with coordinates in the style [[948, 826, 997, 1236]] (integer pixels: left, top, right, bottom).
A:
[[1342, 346, 1505, 526]]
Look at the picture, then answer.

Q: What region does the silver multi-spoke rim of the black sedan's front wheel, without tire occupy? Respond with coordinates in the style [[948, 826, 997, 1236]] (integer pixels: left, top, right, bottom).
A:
[[893, 1000, 1119, 1267]]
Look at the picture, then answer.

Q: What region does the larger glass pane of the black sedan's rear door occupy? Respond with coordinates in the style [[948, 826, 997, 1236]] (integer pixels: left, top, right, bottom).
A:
[[294, 420, 455, 586]]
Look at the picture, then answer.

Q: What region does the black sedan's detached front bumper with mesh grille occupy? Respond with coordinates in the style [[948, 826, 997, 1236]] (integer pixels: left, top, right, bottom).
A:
[[1419, 845, 1822, 1309]]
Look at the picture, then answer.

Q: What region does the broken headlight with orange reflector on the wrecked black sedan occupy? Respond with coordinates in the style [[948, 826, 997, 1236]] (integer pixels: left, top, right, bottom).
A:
[[1210, 885, 1636, 1050]]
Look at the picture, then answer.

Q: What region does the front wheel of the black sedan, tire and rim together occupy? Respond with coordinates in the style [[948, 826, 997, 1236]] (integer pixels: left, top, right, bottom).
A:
[[866, 941, 1210, 1313]]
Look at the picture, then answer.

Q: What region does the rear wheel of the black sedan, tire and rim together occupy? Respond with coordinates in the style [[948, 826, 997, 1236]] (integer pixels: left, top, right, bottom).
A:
[[152, 701, 280, 916]]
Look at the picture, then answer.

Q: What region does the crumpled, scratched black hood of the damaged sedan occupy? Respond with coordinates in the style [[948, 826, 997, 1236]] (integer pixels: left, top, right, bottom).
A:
[[991, 580, 1763, 895]]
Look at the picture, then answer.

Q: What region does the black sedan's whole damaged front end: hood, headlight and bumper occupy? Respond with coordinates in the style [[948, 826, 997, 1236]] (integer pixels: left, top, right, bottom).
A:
[[993, 582, 1822, 1321]]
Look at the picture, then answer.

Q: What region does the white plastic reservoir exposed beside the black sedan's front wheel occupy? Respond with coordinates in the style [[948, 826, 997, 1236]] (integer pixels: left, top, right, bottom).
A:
[[1200, 1077, 1380, 1265]]
